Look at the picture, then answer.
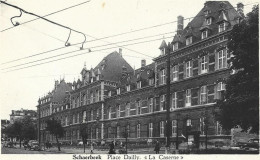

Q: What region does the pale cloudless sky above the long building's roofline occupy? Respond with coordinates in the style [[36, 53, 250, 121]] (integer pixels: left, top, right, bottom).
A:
[[0, 0, 257, 119]]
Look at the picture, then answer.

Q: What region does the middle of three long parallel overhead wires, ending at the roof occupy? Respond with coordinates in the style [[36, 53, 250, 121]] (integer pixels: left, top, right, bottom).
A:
[[1, 31, 176, 70]]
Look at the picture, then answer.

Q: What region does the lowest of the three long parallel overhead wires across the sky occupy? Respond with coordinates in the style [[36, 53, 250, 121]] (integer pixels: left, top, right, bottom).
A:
[[3, 36, 177, 73]]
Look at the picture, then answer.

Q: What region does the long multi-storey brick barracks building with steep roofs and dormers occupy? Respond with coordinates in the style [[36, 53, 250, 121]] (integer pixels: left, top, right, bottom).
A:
[[38, 1, 243, 148]]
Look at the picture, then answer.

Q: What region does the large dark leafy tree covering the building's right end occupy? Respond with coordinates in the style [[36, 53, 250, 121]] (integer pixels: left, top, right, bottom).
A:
[[217, 5, 259, 133]]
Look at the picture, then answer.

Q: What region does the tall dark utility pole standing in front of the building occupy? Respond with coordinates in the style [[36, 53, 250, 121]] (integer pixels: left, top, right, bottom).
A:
[[165, 44, 171, 150]]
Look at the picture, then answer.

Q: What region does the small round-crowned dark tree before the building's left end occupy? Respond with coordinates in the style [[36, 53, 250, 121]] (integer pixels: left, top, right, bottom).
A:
[[46, 119, 64, 151]]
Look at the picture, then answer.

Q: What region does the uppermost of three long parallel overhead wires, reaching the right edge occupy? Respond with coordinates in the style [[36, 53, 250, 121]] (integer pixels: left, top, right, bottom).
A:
[[0, 1, 258, 65]]
